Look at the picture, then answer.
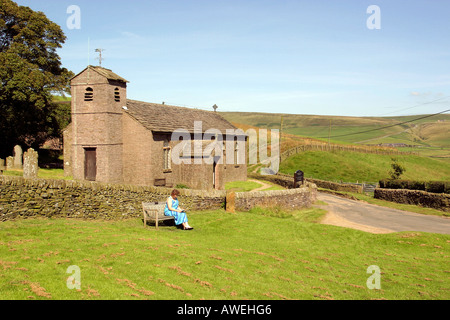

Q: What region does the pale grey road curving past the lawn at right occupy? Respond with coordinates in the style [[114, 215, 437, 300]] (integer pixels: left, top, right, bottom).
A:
[[317, 192, 450, 234]]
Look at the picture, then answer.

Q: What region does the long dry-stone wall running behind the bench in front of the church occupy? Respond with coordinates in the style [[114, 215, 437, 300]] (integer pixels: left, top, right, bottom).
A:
[[0, 176, 316, 221]]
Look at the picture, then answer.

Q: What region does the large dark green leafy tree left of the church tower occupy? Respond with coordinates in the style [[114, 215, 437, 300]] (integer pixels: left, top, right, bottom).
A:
[[0, 0, 73, 158]]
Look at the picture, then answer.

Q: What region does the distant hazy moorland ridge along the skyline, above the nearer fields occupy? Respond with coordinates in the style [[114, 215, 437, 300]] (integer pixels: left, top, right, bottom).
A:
[[221, 112, 450, 149]]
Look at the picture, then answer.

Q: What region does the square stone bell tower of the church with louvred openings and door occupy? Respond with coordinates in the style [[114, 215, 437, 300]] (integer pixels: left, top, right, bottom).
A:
[[70, 66, 128, 183]]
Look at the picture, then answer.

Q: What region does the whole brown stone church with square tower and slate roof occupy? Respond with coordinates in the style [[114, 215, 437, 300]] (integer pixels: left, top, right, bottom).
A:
[[64, 66, 247, 190]]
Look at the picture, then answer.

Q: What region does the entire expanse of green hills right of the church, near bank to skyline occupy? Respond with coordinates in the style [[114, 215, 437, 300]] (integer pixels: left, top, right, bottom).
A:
[[221, 112, 450, 182]]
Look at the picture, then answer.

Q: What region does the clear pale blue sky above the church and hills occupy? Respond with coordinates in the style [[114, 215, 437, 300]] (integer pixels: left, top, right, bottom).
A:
[[16, 0, 450, 116]]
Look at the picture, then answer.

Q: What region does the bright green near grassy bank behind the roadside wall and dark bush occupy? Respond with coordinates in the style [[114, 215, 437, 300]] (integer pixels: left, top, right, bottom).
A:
[[280, 151, 450, 182]]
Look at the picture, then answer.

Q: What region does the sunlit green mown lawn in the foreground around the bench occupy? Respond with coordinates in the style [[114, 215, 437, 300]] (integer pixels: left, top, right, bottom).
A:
[[0, 208, 450, 300]]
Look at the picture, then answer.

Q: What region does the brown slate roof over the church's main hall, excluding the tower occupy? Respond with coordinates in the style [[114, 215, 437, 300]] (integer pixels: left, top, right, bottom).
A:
[[124, 99, 243, 134]]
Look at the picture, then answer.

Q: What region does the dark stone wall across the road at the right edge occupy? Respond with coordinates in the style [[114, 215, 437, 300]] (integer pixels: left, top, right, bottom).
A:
[[374, 188, 450, 212]]
